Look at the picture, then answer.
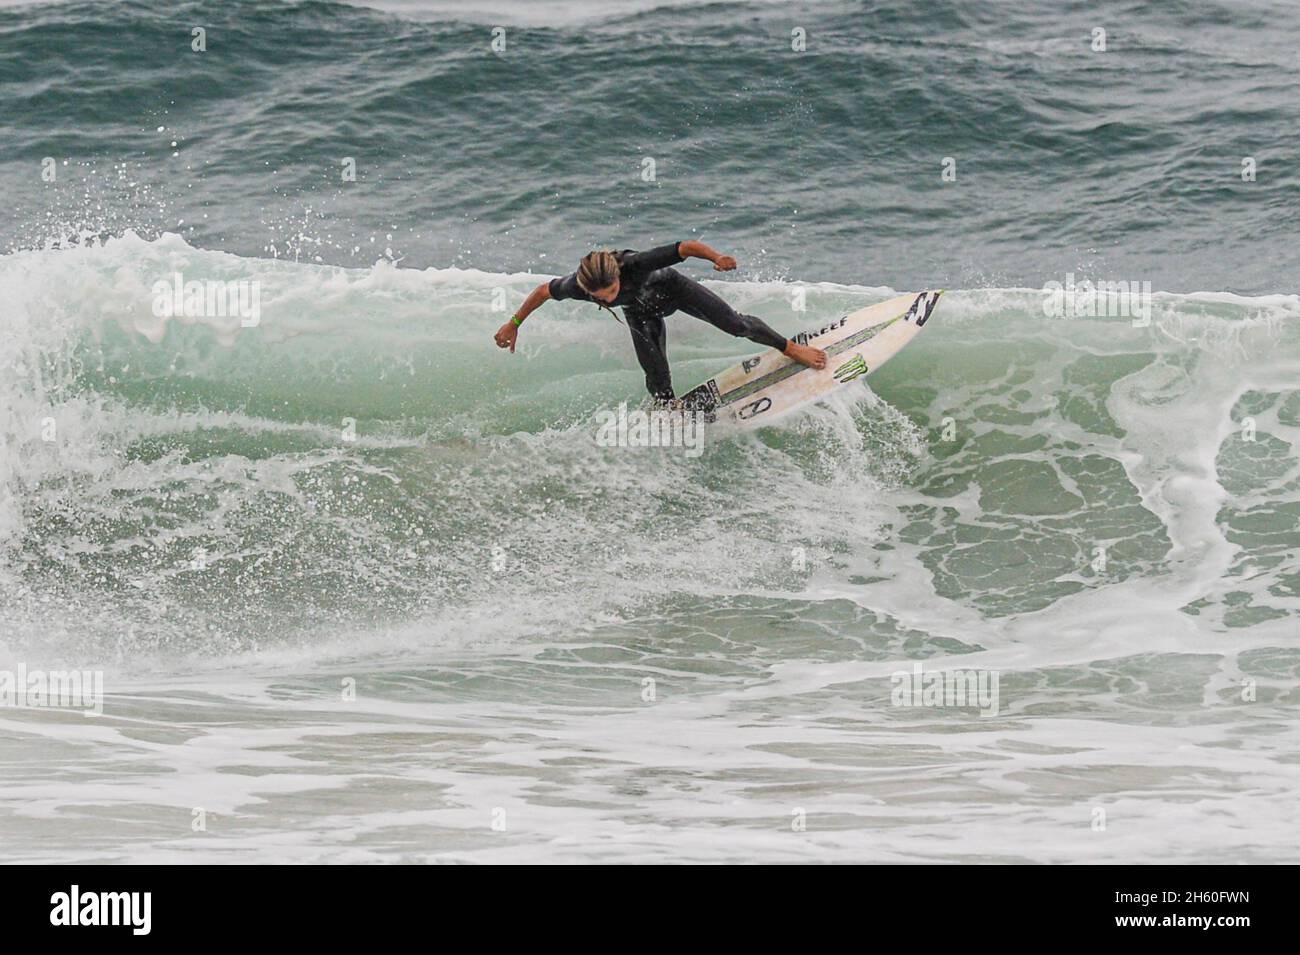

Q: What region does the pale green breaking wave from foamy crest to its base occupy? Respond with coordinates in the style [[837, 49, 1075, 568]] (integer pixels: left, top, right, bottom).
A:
[[0, 235, 1300, 652]]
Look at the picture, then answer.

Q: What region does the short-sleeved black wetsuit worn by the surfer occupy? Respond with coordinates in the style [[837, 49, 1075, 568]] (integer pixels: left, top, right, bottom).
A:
[[550, 242, 785, 400]]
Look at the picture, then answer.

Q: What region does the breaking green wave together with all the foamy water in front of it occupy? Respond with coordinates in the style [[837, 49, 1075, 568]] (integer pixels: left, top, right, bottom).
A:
[[0, 231, 1300, 861]]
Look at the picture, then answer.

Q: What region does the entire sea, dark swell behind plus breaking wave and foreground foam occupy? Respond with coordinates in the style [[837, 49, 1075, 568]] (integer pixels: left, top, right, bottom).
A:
[[0, 0, 1300, 863]]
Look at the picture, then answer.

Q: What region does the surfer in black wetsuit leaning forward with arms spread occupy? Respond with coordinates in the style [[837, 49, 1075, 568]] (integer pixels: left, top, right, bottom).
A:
[[497, 239, 826, 401]]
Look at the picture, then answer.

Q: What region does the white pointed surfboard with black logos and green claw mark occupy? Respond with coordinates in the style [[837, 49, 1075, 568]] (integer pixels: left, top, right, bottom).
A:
[[681, 291, 944, 426]]
